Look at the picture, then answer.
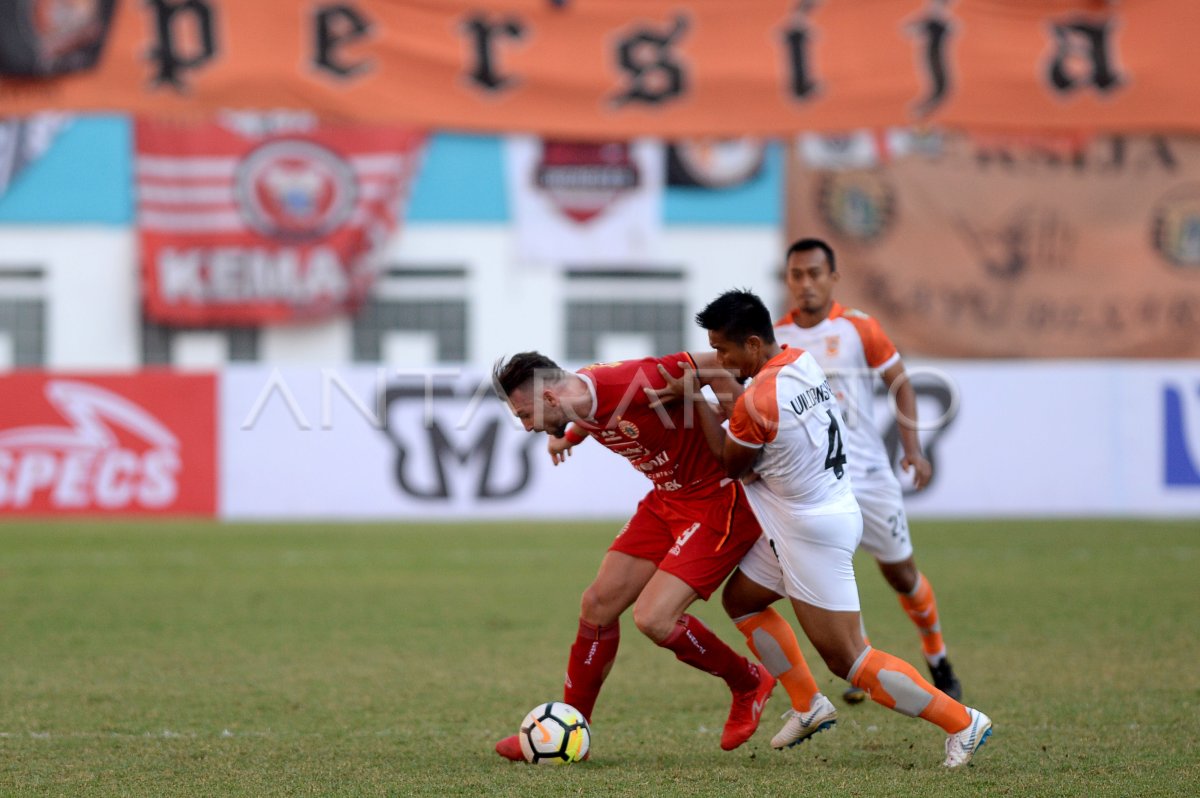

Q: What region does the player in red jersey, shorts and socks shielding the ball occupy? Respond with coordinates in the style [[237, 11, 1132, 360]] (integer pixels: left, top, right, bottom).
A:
[[492, 352, 775, 761]]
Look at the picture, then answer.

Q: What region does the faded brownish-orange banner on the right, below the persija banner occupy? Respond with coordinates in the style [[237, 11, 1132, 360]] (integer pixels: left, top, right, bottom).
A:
[[787, 132, 1200, 358]]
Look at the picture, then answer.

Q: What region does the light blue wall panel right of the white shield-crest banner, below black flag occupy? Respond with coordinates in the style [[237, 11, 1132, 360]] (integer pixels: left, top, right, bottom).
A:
[[662, 142, 784, 224]]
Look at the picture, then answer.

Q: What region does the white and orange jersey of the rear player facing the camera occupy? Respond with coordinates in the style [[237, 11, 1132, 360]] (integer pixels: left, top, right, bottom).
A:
[[775, 302, 900, 476]]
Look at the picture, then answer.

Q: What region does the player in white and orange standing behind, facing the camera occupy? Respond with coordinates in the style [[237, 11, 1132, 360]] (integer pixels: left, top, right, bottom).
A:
[[775, 239, 962, 703]]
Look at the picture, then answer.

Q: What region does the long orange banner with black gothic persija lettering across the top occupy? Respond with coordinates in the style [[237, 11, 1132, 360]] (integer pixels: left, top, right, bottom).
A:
[[0, 0, 1200, 138]]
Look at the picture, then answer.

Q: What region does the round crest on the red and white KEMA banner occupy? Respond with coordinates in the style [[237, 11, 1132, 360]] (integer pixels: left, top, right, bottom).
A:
[[236, 139, 358, 240]]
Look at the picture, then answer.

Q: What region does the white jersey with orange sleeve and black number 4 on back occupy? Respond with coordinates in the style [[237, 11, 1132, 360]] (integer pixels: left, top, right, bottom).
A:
[[728, 348, 857, 514]]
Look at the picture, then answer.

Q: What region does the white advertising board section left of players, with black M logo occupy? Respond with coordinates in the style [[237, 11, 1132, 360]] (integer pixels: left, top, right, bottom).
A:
[[220, 366, 650, 520]]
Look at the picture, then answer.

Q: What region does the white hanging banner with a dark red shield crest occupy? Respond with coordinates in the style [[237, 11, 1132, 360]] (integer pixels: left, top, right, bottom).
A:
[[505, 136, 666, 266]]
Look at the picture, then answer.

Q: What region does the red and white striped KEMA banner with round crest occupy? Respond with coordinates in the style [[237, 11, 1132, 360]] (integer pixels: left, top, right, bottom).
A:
[[136, 113, 425, 325]]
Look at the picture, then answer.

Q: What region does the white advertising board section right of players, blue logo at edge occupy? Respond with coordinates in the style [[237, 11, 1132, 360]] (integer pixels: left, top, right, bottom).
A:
[[877, 361, 1200, 517]]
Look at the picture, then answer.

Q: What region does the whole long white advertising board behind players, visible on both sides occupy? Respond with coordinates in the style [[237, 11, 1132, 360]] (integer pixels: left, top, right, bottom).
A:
[[220, 361, 1200, 521]]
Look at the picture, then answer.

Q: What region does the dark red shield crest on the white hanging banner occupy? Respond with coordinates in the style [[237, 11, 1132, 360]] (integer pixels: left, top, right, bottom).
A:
[[534, 142, 641, 224]]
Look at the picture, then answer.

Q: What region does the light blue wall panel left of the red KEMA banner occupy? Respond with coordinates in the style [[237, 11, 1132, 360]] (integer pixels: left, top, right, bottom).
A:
[[0, 116, 133, 224]]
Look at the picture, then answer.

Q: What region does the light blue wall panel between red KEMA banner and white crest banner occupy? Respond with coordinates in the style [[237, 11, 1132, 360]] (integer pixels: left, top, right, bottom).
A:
[[407, 133, 509, 222]]
